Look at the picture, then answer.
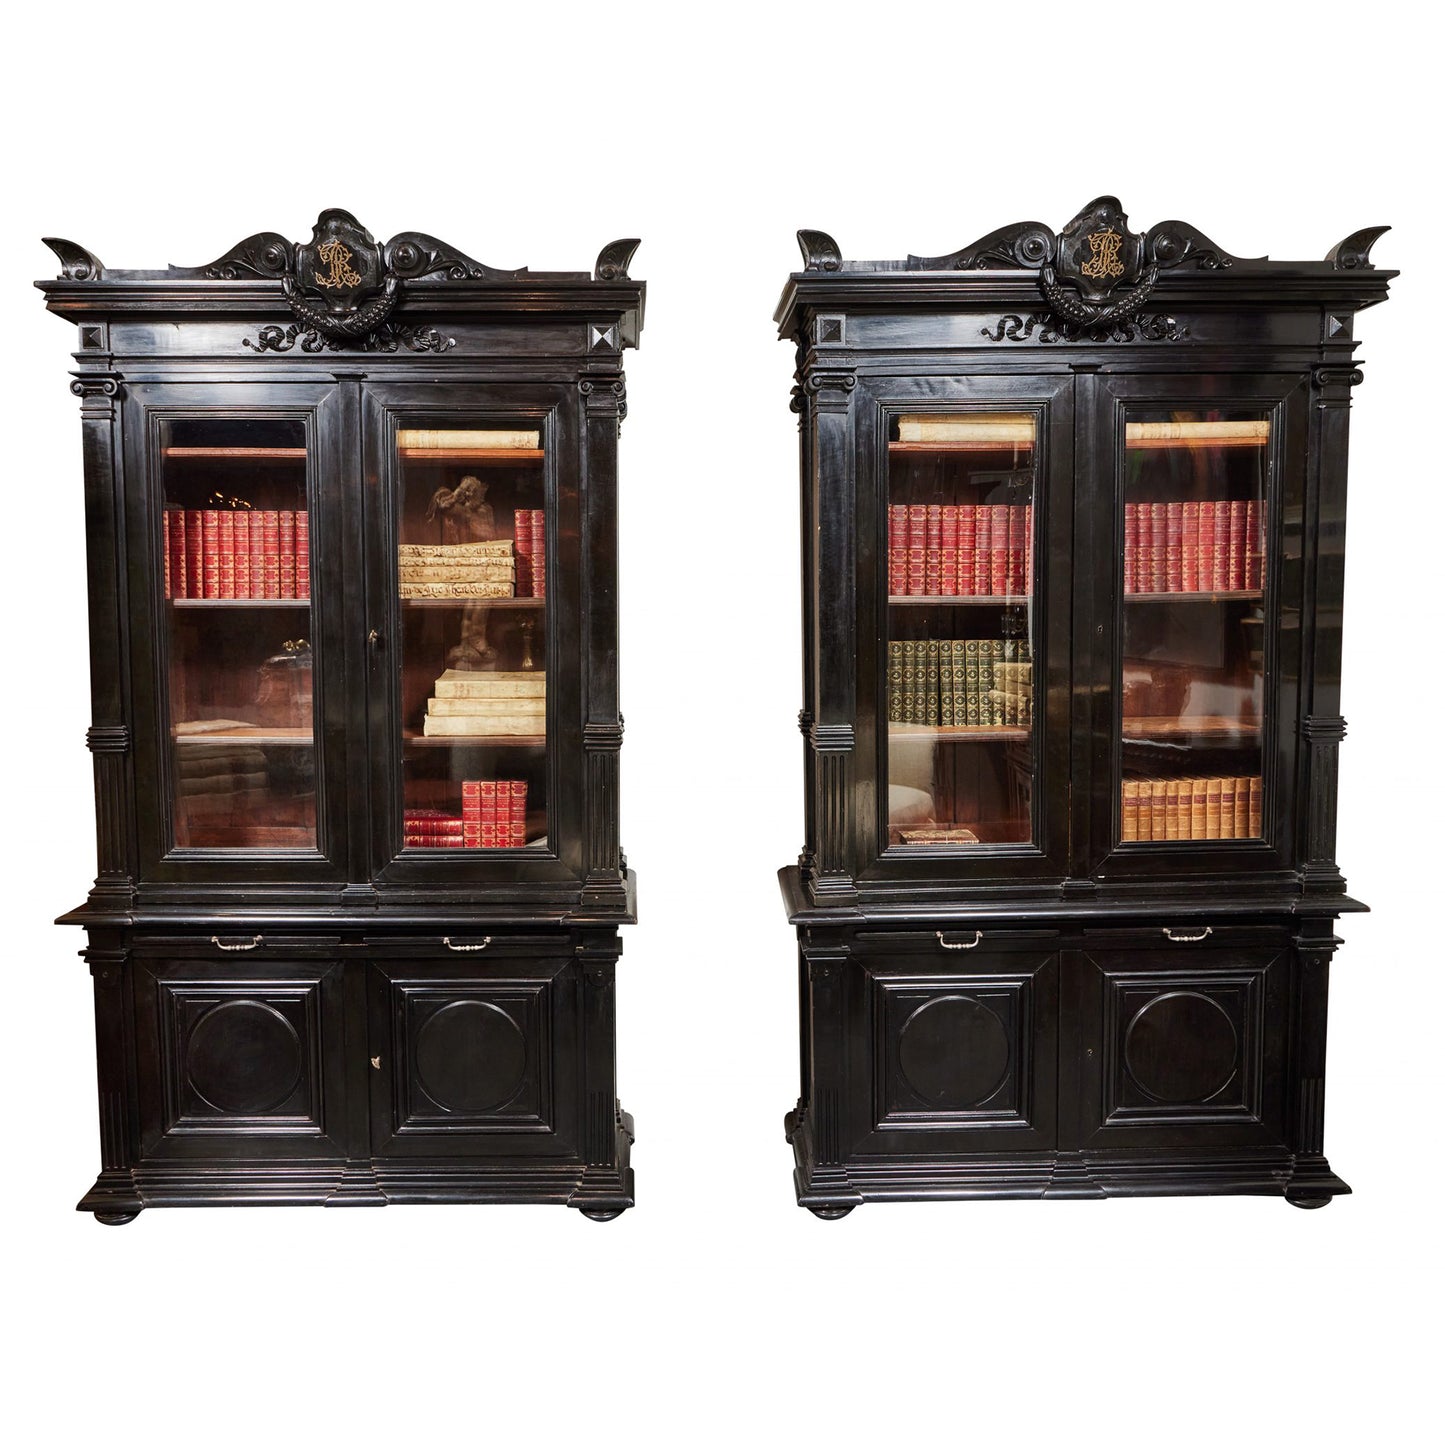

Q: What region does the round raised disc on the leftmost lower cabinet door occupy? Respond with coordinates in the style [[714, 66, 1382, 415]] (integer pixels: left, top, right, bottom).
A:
[[185, 998, 302, 1114]]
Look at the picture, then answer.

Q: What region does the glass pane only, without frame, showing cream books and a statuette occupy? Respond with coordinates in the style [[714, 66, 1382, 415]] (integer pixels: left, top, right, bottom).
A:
[[396, 420, 549, 848]]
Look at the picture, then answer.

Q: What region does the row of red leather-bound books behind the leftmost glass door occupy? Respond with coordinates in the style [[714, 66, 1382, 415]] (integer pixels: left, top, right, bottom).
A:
[[160, 504, 311, 601]]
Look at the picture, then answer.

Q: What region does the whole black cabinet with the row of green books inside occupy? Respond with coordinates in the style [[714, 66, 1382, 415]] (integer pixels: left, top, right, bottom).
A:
[[776, 197, 1396, 1218]]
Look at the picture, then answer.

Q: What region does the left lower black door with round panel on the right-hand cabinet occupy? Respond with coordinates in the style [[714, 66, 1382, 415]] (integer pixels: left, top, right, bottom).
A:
[[845, 929, 1059, 1156]]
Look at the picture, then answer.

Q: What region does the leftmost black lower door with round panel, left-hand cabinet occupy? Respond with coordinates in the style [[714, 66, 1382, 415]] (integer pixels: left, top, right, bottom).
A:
[[134, 938, 360, 1163]]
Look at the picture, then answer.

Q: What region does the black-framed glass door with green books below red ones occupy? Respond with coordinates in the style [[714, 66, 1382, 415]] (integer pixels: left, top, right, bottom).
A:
[[864, 377, 1072, 881]]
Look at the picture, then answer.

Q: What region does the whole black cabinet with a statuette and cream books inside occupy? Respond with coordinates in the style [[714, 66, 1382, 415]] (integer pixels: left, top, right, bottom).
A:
[[38, 211, 644, 1224]]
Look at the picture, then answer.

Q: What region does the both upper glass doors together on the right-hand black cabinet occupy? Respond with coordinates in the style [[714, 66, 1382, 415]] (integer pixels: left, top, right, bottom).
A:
[[854, 373, 1303, 879]]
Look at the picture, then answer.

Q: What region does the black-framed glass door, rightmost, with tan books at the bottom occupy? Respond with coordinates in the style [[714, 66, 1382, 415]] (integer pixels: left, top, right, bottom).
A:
[[1086, 379, 1299, 866]]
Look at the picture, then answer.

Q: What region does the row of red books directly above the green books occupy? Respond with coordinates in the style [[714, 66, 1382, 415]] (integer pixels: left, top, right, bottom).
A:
[[889, 504, 1033, 597]]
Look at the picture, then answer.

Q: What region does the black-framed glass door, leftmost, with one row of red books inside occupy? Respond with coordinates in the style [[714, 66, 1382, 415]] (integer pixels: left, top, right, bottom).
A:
[[127, 386, 347, 881]]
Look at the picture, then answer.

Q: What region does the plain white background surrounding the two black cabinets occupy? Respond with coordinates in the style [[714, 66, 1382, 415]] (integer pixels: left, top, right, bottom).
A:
[[0, 0, 1442, 1442]]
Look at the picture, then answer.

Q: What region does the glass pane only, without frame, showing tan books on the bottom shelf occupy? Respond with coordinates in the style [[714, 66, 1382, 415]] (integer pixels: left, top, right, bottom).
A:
[[1120, 407, 1270, 842]]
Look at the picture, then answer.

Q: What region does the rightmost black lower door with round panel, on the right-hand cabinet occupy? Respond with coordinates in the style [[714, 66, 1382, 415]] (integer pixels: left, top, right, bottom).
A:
[[1064, 928, 1292, 1150]]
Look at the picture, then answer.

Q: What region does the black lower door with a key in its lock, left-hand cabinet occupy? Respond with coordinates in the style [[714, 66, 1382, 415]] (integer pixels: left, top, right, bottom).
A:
[[367, 939, 581, 1159]]
